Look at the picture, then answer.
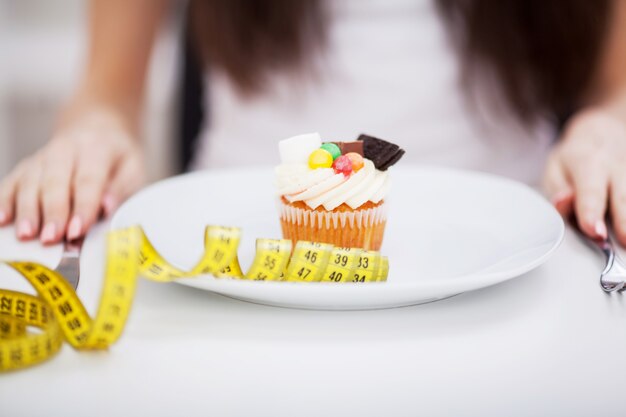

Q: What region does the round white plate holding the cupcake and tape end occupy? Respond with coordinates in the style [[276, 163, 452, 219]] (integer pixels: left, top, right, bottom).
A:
[[112, 167, 564, 310]]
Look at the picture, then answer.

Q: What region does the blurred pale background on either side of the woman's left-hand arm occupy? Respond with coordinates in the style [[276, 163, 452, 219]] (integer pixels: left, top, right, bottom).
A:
[[0, 0, 183, 179]]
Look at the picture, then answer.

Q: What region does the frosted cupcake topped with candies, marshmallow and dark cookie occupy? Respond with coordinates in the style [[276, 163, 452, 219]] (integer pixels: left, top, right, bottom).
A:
[[275, 133, 404, 250]]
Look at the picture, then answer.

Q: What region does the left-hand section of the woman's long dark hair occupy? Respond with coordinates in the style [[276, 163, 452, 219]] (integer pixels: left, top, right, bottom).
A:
[[189, 0, 327, 94]]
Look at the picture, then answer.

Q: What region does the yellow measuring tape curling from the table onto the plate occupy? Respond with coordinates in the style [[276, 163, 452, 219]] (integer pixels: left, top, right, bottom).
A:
[[0, 226, 389, 372]]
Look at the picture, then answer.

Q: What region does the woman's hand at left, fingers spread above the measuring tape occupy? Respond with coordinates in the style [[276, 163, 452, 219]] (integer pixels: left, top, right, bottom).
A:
[[0, 106, 144, 244]]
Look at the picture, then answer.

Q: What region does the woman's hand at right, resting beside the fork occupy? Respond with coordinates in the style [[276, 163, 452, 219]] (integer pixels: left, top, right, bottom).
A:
[[545, 108, 626, 245]]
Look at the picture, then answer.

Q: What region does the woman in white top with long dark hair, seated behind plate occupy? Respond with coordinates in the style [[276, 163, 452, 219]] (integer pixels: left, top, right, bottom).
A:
[[0, 0, 626, 244]]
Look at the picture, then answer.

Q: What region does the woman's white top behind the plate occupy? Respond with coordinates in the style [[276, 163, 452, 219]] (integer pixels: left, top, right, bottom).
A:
[[194, 0, 553, 183]]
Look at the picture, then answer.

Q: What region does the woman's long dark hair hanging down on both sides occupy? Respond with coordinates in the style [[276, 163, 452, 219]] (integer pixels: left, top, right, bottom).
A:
[[190, 0, 613, 121]]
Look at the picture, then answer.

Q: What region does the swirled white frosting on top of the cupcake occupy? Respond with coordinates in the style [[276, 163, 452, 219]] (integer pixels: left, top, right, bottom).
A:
[[275, 159, 389, 210]]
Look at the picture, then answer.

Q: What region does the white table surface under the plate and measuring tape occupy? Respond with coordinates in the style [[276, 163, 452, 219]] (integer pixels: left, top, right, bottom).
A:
[[0, 219, 626, 417]]
